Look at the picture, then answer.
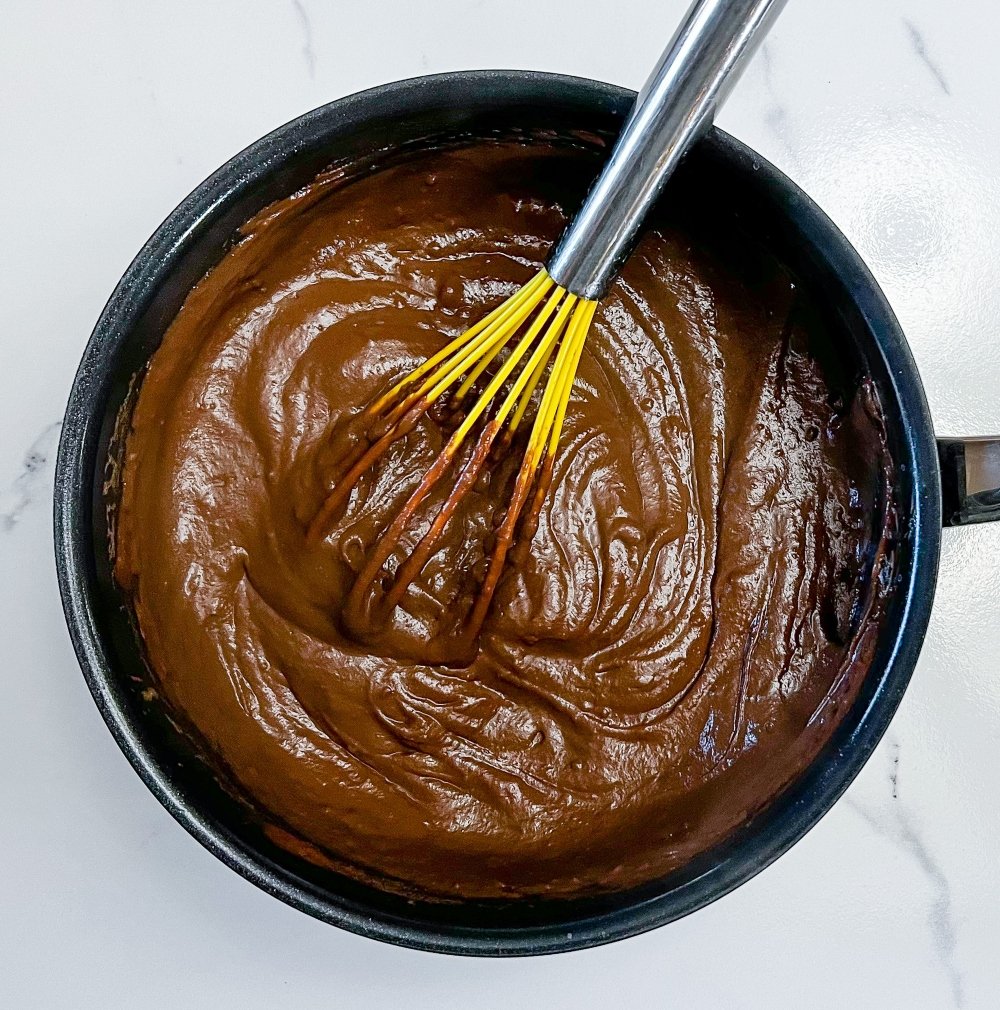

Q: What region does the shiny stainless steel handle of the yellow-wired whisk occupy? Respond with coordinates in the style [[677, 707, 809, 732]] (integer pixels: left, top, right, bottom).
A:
[[547, 0, 786, 298]]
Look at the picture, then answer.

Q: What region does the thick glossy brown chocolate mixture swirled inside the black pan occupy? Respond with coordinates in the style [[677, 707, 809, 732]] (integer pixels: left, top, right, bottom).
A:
[[116, 142, 893, 897]]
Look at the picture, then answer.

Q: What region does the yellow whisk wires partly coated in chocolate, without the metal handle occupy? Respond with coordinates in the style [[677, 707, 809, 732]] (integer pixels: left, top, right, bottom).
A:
[[307, 270, 597, 649]]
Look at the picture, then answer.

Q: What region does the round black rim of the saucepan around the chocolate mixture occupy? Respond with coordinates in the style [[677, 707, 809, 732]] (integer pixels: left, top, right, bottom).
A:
[[55, 71, 941, 955]]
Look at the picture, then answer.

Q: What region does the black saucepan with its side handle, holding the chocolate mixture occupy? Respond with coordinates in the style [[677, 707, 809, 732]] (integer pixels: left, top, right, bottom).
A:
[[56, 72, 1000, 955]]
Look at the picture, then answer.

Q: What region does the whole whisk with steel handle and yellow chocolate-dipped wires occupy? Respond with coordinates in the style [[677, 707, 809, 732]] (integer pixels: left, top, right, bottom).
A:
[[307, 0, 785, 662]]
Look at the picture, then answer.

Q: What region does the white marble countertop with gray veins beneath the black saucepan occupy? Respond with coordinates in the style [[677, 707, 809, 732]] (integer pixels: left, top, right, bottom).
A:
[[0, 0, 1000, 1010]]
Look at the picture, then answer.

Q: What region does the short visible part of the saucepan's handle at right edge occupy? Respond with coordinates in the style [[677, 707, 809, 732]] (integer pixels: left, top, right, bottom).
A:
[[937, 435, 1000, 526]]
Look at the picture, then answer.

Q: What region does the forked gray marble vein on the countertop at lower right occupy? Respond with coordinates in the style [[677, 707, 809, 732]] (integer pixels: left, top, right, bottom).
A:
[[844, 783, 965, 1008]]
